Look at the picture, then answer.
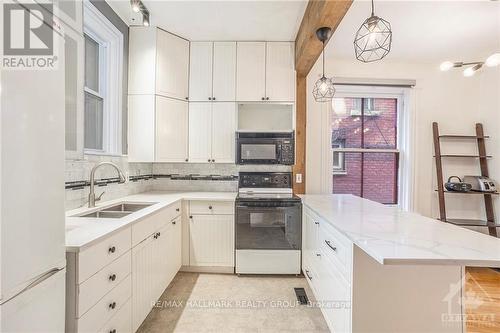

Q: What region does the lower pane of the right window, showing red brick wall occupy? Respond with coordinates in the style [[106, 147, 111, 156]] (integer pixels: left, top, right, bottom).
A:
[[332, 153, 399, 204]]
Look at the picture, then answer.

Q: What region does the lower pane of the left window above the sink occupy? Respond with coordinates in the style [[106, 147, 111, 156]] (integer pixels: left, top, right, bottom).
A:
[[84, 92, 103, 150]]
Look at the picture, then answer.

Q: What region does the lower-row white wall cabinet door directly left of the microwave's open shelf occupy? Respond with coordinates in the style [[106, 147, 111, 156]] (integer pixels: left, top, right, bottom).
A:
[[212, 103, 236, 163]]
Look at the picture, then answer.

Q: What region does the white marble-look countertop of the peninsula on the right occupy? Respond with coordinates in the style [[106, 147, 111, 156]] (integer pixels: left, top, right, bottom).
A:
[[300, 194, 500, 267]]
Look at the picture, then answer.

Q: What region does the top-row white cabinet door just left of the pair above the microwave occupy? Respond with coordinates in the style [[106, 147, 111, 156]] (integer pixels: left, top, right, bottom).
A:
[[212, 42, 236, 102]]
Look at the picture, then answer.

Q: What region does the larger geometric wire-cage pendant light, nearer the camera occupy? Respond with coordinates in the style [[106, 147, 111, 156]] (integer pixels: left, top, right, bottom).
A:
[[354, 0, 392, 62]]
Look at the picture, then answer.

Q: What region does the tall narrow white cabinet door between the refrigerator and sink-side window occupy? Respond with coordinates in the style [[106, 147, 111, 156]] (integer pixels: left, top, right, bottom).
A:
[[64, 22, 85, 159]]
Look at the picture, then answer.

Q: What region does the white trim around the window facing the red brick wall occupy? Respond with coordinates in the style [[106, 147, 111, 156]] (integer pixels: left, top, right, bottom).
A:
[[321, 85, 415, 211]]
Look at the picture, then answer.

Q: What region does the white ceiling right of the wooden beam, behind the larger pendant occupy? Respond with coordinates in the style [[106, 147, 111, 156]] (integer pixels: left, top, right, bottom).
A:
[[327, 0, 500, 62]]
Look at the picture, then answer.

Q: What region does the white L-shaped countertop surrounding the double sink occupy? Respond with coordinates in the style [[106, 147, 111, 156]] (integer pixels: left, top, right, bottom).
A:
[[66, 191, 237, 252]]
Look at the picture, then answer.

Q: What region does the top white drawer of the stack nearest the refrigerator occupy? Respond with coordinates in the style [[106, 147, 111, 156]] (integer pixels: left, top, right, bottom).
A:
[[78, 227, 131, 284]]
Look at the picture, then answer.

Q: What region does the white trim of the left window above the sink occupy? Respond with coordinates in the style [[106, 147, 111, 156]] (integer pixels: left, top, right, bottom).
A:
[[83, 0, 124, 155]]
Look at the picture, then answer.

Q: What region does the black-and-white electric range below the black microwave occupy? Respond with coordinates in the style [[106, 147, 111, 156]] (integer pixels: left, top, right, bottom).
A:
[[235, 172, 302, 274]]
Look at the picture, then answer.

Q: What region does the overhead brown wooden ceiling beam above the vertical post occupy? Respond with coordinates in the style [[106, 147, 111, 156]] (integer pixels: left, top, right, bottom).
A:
[[295, 0, 354, 76]]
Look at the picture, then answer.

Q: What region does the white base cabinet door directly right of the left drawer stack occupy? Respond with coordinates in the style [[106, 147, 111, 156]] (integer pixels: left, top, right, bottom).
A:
[[132, 236, 156, 332]]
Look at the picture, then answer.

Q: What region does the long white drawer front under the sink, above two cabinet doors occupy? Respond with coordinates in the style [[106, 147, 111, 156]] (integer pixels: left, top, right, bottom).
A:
[[132, 200, 181, 247]]
